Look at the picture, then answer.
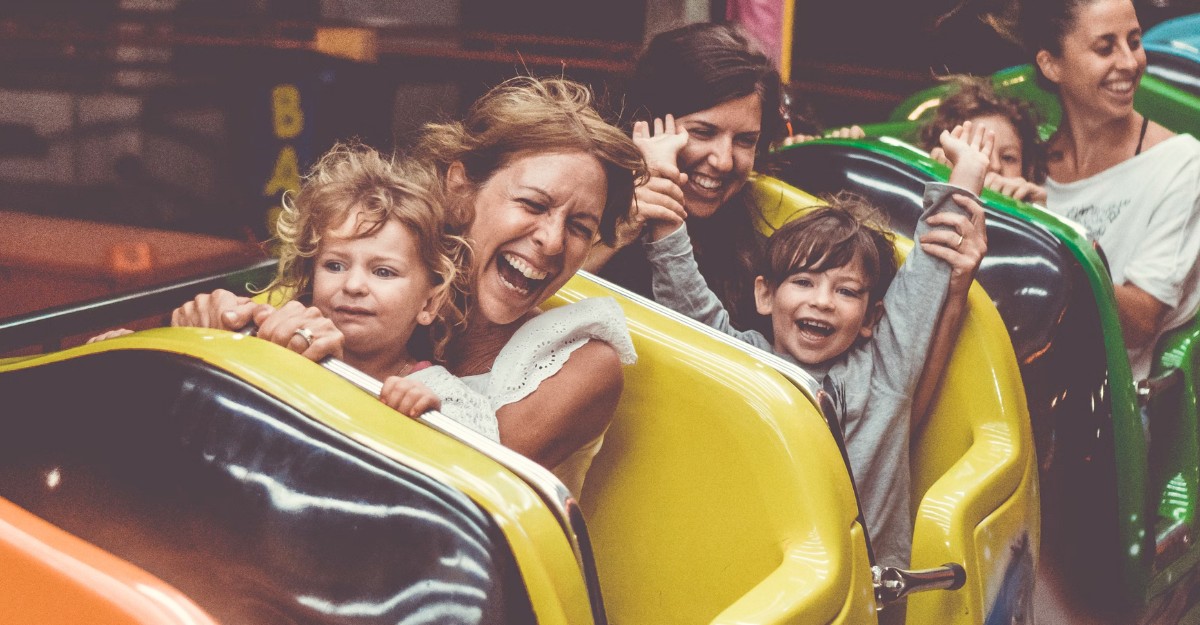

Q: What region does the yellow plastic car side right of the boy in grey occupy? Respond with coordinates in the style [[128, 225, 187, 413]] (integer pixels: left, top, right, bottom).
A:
[[908, 284, 1040, 624]]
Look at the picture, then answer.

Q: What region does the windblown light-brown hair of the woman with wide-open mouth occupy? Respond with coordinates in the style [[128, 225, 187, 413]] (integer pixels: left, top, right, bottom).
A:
[[416, 77, 647, 245]]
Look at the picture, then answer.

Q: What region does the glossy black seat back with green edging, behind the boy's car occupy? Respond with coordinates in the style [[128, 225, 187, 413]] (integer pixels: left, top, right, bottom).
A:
[[763, 143, 1123, 609]]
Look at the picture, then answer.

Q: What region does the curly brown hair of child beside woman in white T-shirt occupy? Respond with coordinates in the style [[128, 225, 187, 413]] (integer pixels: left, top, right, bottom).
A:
[[920, 76, 1046, 184]]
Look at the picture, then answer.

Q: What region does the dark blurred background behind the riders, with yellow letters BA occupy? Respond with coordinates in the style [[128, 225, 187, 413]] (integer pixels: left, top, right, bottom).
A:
[[0, 0, 1200, 319]]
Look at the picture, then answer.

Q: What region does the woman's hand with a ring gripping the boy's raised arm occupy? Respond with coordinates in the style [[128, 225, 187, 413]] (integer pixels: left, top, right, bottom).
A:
[[920, 194, 988, 296]]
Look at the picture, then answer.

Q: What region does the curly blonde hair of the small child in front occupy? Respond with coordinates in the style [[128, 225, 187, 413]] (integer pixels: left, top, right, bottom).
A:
[[266, 143, 470, 360]]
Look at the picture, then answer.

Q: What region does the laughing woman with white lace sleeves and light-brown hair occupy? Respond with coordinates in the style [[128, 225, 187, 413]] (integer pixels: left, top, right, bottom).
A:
[[173, 78, 644, 495]]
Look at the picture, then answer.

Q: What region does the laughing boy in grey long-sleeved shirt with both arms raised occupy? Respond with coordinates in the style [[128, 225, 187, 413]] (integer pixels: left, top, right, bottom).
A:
[[635, 124, 992, 567]]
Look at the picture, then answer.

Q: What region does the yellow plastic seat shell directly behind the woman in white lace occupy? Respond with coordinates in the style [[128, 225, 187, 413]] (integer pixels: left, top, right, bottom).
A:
[[554, 277, 874, 624]]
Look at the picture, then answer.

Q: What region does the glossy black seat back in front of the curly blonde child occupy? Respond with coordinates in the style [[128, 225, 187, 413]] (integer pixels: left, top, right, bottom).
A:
[[0, 350, 534, 625]]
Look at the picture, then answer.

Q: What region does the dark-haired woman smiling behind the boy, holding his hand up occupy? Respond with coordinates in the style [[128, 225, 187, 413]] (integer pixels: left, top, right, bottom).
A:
[[586, 24, 786, 331]]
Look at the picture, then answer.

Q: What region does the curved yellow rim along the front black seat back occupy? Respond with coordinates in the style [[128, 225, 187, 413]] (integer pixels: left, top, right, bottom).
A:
[[0, 327, 593, 625]]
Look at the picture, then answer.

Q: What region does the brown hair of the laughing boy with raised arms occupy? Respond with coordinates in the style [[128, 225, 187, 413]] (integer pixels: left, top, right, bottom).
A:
[[761, 192, 896, 306]]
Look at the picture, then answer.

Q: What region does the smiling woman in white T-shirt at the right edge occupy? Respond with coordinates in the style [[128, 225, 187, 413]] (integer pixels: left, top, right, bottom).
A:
[[1018, 0, 1200, 379]]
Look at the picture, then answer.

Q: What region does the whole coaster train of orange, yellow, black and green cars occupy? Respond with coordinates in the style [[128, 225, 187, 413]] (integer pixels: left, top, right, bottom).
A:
[[0, 46, 1200, 625]]
